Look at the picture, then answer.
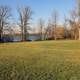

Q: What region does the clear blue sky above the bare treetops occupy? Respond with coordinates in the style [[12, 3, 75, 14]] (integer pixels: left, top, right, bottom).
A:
[[0, 0, 76, 23]]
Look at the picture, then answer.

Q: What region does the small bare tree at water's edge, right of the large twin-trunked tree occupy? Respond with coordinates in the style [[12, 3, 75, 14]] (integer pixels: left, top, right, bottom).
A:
[[38, 18, 44, 40]]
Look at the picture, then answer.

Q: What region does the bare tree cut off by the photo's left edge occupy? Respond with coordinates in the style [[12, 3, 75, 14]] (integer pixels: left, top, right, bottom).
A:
[[0, 6, 11, 39]]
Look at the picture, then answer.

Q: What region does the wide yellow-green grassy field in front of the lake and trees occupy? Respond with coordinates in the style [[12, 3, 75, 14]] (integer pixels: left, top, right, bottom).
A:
[[0, 41, 80, 80]]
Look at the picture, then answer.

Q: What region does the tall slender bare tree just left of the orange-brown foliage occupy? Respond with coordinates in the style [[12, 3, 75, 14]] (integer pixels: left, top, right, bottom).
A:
[[52, 10, 59, 40]]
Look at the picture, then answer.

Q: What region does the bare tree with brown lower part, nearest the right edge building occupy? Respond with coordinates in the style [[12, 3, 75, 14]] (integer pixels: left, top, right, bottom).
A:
[[69, 10, 79, 40]]
